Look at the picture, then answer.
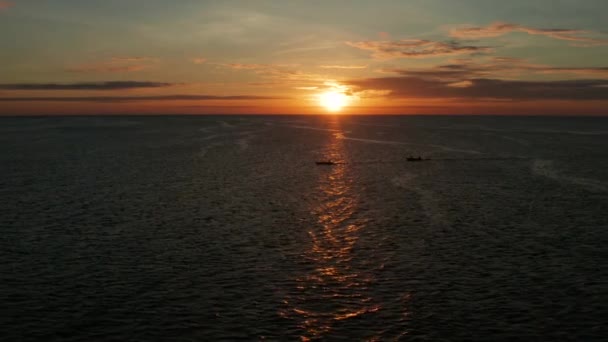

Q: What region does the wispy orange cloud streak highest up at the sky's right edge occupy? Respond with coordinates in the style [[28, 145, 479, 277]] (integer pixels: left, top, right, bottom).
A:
[[450, 22, 608, 45]]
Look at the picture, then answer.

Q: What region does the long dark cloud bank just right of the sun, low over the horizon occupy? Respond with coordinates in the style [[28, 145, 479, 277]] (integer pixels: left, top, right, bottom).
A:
[[346, 76, 608, 100]]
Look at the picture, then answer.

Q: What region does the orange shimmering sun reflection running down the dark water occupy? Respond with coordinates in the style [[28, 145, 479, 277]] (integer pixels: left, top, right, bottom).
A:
[[282, 122, 381, 341]]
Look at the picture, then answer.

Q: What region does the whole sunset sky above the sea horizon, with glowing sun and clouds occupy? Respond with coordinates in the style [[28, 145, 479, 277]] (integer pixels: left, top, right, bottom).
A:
[[0, 0, 608, 115]]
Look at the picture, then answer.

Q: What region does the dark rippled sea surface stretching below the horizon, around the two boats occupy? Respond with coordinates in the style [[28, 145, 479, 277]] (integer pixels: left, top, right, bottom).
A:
[[0, 116, 608, 341]]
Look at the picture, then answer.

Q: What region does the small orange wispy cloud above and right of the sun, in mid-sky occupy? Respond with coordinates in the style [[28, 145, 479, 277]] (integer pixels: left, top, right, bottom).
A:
[[346, 39, 491, 59]]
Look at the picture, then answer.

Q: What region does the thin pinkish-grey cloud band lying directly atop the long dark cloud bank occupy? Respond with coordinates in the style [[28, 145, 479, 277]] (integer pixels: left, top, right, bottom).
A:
[[382, 57, 608, 81]]
